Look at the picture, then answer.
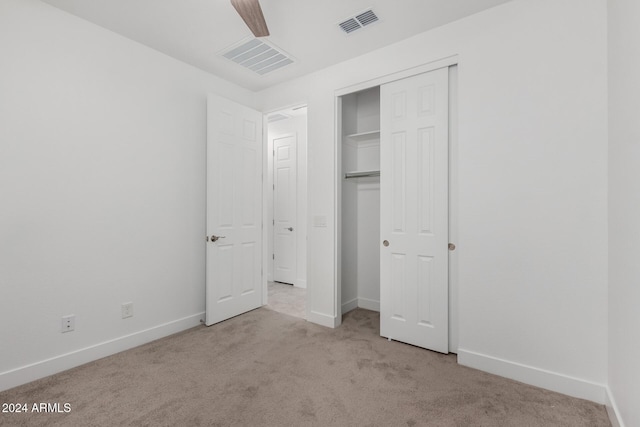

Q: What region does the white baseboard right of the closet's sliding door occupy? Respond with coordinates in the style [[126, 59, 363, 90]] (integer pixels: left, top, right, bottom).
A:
[[458, 348, 606, 404]]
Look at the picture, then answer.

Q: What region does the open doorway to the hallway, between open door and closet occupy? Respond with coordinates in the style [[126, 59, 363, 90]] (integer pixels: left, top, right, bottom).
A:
[[266, 105, 307, 318]]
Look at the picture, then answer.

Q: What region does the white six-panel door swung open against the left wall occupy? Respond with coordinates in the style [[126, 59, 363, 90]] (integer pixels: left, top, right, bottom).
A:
[[205, 95, 264, 325]]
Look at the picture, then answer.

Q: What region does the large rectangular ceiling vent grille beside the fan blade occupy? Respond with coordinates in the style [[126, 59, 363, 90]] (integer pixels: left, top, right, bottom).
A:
[[222, 39, 293, 75]]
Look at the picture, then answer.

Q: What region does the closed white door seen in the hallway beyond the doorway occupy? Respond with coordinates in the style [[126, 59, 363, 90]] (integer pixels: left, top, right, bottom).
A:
[[273, 134, 297, 284]]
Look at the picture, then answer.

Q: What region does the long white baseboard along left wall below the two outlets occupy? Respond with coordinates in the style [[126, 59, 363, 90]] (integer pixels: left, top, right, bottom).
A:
[[0, 313, 204, 391]]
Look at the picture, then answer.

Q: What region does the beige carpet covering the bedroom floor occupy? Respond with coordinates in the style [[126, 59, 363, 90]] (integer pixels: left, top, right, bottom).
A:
[[0, 309, 609, 427]]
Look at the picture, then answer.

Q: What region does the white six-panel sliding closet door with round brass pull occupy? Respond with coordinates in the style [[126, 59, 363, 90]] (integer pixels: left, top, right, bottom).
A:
[[380, 68, 449, 353]]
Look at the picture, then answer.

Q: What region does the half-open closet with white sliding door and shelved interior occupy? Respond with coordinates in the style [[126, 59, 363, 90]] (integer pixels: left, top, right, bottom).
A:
[[336, 67, 453, 353]]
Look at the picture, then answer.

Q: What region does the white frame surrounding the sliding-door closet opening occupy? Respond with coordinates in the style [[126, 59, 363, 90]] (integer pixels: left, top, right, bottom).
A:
[[333, 55, 459, 353]]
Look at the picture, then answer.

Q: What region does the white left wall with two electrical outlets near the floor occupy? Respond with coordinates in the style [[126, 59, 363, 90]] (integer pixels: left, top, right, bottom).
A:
[[0, 0, 254, 390]]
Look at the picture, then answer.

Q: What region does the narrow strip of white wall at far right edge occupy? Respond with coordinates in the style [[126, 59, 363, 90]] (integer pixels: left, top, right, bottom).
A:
[[608, 0, 640, 426]]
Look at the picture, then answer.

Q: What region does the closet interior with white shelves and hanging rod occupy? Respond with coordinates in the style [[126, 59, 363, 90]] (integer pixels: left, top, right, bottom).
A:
[[341, 87, 380, 313]]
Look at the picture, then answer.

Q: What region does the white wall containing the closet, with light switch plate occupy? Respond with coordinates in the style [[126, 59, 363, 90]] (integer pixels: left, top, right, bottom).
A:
[[260, 0, 607, 401]]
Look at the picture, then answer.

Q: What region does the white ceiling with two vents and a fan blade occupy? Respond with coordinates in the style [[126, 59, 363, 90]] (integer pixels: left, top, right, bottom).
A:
[[43, 0, 510, 91]]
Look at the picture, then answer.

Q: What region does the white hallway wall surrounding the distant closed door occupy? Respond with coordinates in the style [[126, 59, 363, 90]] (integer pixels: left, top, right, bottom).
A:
[[267, 114, 307, 288]]
